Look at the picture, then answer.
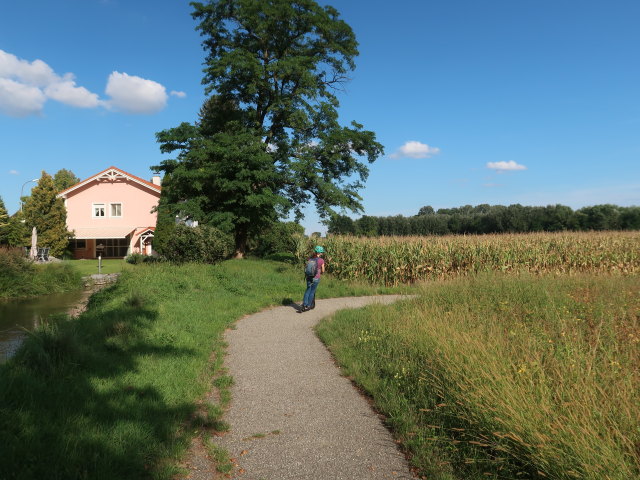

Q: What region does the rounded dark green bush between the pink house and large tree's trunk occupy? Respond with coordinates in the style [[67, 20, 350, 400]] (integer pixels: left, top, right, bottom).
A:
[[164, 225, 233, 263]]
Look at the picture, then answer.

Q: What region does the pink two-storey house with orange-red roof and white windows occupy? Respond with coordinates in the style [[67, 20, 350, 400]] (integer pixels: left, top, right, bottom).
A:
[[58, 167, 160, 258]]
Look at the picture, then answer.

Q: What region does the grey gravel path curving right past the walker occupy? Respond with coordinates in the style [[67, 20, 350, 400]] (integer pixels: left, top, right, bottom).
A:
[[206, 295, 414, 480]]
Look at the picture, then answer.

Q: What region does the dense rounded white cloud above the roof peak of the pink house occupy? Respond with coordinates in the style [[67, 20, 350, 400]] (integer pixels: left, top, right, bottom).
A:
[[105, 72, 167, 113]]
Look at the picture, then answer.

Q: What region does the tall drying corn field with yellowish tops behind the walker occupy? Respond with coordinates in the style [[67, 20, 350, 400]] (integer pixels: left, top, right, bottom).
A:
[[299, 232, 640, 286]]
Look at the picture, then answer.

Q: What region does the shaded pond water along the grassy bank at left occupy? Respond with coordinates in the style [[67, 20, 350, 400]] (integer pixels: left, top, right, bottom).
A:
[[0, 290, 92, 363]]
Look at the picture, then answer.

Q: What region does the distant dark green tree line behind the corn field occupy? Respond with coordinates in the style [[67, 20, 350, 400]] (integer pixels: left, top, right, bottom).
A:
[[328, 204, 640, 237]]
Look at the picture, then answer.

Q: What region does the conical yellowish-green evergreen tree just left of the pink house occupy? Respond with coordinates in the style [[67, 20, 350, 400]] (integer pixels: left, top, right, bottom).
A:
[[23, 170, 71, 257]]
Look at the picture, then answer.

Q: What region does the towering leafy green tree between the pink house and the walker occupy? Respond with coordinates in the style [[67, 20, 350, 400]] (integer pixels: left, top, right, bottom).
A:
[[157, 0, 383, 256]]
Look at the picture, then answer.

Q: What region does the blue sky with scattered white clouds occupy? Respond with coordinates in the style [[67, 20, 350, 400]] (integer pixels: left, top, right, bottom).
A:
[[0, 0, 640, 233]]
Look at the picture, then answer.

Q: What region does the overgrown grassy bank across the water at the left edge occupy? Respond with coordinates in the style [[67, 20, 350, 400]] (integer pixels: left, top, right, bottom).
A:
[[0, 248, 82, 299]]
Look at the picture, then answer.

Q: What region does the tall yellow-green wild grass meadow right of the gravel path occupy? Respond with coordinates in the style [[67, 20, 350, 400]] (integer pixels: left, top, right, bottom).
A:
[[318, 274, 640, 480]]
